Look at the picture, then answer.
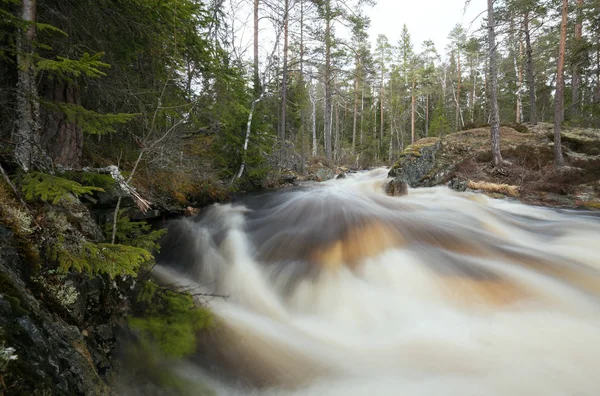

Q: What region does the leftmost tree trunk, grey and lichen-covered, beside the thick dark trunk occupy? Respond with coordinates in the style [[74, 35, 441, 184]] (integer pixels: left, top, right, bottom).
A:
[[12, 0, 40, 172]]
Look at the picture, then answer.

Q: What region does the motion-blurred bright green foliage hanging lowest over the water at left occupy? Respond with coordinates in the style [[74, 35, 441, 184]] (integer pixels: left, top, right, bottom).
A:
[[129, 281, 213, 358]]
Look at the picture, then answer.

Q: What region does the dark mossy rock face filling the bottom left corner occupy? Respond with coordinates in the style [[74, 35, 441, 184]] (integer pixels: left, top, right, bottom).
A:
[[0, 225, 110, 395]]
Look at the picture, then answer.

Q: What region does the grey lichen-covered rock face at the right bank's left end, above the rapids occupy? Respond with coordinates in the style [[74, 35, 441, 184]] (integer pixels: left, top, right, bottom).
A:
[[388, 138, 441, 187]]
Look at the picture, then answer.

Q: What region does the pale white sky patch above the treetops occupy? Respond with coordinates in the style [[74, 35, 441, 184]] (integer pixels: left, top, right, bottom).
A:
[[365, 0, 487, 54]]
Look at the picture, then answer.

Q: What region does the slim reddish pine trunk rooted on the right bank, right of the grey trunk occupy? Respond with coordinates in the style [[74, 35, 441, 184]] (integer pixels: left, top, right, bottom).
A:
[[554, 0, 569, 167]]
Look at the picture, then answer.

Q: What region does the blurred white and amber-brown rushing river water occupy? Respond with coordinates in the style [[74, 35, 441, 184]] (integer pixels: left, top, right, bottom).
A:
[[156, 169, 600, 396]]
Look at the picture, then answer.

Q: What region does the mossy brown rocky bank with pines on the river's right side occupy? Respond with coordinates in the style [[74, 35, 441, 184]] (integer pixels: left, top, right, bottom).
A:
[[390, 123, 600, 210]]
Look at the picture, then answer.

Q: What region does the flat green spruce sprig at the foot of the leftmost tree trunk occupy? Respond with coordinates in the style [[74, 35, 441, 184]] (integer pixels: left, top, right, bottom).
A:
[[21, 172, 104, 205]]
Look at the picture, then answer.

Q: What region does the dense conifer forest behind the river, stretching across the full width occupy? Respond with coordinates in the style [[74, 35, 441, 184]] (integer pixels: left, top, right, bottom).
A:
[[0, 0, 600, 191]]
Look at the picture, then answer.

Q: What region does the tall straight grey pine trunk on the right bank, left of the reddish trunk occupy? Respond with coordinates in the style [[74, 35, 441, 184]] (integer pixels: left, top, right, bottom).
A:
[[487, 0, 504, 167]]
